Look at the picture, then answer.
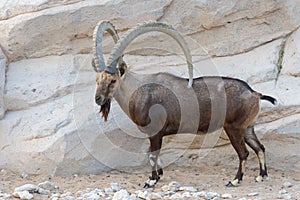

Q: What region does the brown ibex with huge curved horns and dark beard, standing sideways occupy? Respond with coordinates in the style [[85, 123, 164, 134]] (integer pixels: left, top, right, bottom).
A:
[[92, 21, 276, 188]]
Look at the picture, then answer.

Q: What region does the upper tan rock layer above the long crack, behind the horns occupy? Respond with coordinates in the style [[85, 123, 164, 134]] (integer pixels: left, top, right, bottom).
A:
[[0, 0, 300, 60]]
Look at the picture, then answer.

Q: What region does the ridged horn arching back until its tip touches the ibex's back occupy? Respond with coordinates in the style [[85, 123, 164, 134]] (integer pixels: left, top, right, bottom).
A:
[[106, 22, 193, 87]]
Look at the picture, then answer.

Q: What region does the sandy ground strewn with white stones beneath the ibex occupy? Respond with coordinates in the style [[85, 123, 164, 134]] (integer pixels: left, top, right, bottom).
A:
[[0, 147, 300, 200]]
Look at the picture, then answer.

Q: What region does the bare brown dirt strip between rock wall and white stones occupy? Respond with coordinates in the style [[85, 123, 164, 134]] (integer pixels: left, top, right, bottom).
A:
[[0, 166, 300, 199]]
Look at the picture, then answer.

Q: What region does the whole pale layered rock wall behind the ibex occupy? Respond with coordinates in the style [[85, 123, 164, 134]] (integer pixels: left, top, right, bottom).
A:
[[0, 0, 300, 174]]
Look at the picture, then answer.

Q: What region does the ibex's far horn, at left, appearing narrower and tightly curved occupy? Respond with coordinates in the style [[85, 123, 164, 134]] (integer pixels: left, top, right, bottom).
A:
[[93, 21, 122, 73]]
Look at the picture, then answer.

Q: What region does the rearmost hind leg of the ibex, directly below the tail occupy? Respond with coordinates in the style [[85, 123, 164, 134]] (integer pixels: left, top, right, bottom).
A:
[[245, 127, 268, 181]]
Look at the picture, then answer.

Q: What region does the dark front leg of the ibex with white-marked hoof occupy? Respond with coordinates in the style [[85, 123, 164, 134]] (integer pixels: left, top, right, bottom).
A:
[[144, 133, 163, 188]]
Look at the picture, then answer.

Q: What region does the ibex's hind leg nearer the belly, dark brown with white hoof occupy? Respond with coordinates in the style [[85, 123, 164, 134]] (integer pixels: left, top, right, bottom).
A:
[[225, 127, 249, 187]]
